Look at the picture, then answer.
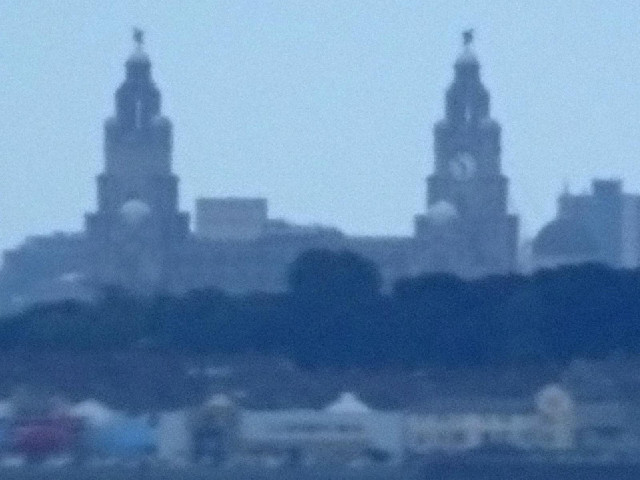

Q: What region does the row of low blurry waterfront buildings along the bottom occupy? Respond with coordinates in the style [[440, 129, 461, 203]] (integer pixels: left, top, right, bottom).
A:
[[5, 384, 640, 468]]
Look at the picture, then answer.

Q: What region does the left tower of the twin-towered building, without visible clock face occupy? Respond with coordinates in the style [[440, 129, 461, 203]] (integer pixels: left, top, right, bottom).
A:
[[86, 29, 189, 291]]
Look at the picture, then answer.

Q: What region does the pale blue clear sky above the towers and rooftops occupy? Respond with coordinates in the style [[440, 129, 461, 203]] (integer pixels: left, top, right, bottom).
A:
[[0, 0, 640, 253]]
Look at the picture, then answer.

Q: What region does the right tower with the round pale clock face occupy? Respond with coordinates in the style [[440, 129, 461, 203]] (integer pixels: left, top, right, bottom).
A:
[[416, 31, 518, 277]]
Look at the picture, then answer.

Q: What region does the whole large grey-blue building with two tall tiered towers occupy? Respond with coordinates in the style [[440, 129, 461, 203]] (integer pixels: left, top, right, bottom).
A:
[[0, 32, 518, 311]]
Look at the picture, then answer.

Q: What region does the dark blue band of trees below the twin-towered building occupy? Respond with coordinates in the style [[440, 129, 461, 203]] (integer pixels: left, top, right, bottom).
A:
[[0, 250, 640, 368]]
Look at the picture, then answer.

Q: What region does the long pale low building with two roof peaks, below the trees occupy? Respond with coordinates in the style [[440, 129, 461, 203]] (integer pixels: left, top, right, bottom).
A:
[[190, 393, 404, 466]]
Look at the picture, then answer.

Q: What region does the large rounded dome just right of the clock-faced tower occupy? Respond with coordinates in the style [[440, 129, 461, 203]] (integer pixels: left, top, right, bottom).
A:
[[533, 218, 600, 257]]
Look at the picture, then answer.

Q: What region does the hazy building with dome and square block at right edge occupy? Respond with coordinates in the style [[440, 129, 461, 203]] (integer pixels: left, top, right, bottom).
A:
[[532, 180, 640, 269]]
